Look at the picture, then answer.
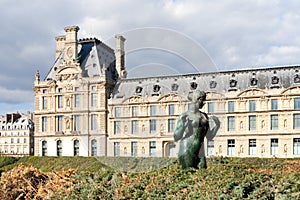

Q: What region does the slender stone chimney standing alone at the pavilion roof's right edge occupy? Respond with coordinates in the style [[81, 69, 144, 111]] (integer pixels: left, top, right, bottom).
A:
[[115, 35, 127, 78]]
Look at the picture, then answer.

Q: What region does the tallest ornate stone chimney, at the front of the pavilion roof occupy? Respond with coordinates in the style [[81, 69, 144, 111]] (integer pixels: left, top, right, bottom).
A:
[[64, 26, 79, 60]]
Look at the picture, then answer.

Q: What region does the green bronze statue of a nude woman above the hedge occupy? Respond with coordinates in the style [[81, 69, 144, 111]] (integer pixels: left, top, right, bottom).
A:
[[174, 90, 220, 169]]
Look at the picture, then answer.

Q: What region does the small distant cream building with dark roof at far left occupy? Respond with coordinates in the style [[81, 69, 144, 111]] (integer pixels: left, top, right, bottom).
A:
[[0, 113, 34, 156]]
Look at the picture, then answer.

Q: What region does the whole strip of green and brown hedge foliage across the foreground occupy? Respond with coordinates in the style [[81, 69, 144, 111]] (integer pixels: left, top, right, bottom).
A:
[[0, 157, 300, 199]]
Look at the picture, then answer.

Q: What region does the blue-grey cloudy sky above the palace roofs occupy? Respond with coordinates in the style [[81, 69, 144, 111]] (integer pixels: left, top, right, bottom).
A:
[[0, 0, 300, 114]]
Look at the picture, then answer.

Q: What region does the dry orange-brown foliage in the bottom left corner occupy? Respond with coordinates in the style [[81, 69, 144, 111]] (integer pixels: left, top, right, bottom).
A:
[[0, 165, 76, 200]]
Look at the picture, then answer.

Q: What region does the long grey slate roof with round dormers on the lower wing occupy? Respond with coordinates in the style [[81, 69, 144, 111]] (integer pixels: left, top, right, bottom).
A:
[[113, 66, 300, 98]]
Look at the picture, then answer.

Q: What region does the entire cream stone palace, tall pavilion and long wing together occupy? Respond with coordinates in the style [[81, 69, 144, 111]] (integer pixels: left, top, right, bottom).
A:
[[34, 26, 300, 158]]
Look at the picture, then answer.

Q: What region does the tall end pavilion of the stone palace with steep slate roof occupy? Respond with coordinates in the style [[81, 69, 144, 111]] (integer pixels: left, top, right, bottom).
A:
[[33, 26, 124, 156]]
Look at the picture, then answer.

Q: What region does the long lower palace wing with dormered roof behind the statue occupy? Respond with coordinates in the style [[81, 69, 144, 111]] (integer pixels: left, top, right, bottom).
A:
[[108, 66, 300, 158]]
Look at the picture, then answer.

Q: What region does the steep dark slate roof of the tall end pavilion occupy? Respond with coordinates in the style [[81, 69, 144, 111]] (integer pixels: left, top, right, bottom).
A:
[[45, 38, 117, 80]]
